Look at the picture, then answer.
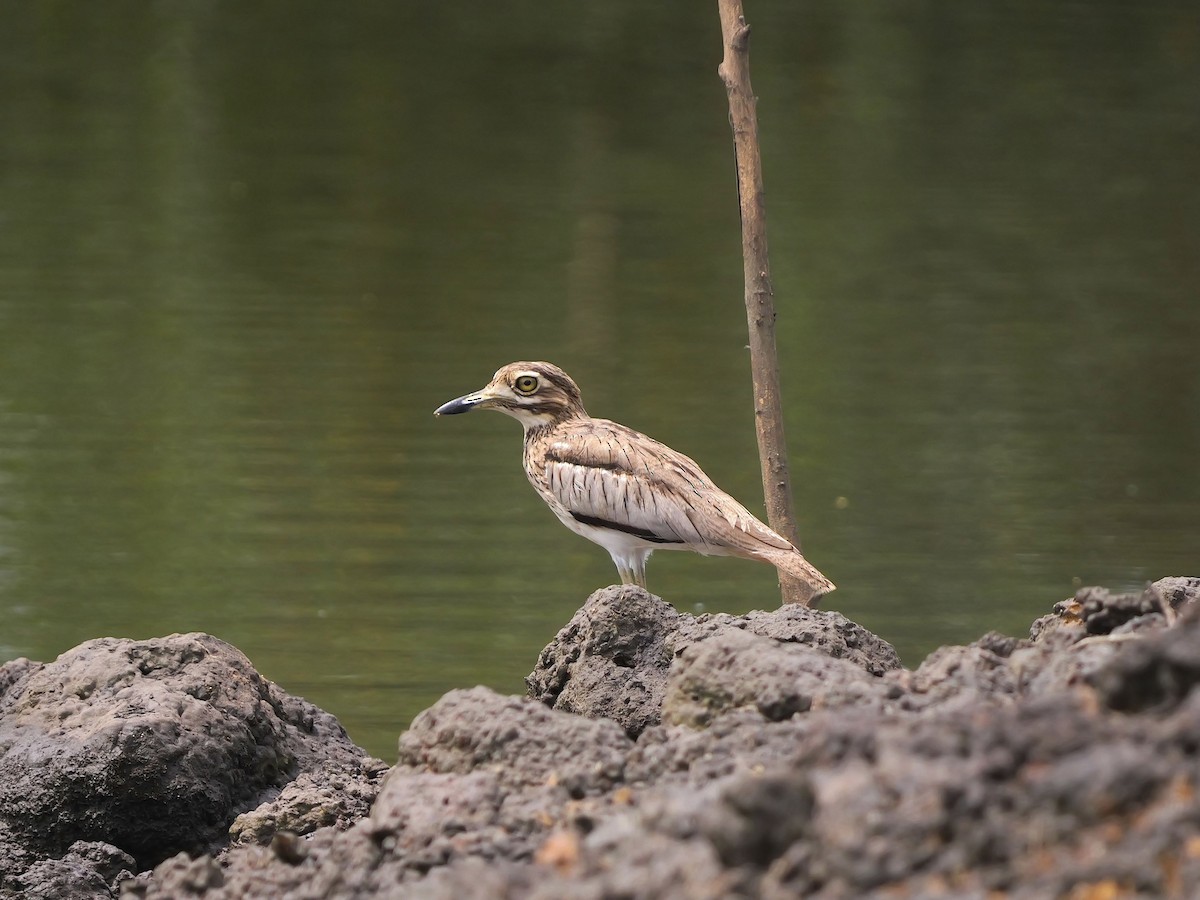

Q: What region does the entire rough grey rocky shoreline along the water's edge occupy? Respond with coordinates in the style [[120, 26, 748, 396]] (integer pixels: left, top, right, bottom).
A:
[[0, 577, 1200, 900]]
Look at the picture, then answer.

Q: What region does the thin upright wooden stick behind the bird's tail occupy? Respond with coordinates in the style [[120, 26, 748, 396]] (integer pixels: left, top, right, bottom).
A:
[[716, 0, 808, 604]]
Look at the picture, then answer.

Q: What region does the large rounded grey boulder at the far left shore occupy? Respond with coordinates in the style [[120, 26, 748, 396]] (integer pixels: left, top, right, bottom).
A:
[[0, 635, 379, 883]]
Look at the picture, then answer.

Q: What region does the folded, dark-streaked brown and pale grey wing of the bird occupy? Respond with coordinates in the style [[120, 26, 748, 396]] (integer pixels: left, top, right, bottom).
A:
[[545, 419, 792, 556]]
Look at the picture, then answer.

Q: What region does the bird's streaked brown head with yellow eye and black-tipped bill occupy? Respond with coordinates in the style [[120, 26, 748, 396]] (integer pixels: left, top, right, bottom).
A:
[[433, 362, 587, 431]]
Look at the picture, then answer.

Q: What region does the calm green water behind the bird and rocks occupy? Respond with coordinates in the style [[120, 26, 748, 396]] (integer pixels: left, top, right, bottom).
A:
[[0, 0, 1200, 757]]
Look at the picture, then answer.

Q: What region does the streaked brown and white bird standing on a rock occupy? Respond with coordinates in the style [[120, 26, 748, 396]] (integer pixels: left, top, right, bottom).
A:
[[433, 361, 834, 604]]
